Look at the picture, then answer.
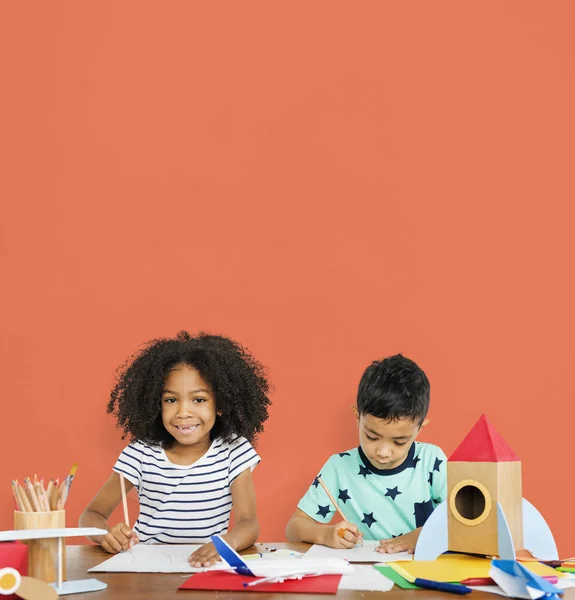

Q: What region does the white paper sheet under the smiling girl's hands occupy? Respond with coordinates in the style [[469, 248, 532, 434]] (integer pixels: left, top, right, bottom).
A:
[[88, 544, 227, 573]]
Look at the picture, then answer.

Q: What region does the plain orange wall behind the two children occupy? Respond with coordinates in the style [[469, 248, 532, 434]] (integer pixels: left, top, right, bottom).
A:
[[0, 0, 575, 555]]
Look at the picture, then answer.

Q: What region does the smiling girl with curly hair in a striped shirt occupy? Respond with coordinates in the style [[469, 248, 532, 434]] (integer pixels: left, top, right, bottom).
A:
[[80, 331, 270, 567]]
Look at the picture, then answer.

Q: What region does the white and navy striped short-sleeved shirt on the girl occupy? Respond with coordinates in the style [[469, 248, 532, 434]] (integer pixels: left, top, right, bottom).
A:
[[114, 437, 260, 544]]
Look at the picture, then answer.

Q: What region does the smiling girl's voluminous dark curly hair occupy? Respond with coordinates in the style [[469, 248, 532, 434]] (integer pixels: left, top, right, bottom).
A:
[[108, 331, 270, 448]]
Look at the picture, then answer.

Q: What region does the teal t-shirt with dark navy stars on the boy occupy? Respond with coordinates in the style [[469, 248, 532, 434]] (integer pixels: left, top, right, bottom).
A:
[[298, 442, 447, 540]]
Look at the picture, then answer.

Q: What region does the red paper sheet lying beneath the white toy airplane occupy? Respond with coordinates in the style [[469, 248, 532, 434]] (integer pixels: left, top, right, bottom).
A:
[[179, 571, 341, 594]]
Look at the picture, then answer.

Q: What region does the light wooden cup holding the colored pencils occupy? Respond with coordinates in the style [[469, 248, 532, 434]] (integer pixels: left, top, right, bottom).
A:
[[14, 510, 66, 583]]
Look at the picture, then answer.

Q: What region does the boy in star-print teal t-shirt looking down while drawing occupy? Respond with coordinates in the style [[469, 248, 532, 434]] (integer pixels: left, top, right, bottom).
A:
[[286, 354, 447, 553]]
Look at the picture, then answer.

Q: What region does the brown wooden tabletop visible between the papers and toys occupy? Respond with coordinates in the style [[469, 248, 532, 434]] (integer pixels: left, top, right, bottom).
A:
[[66, 544, 575, 600]]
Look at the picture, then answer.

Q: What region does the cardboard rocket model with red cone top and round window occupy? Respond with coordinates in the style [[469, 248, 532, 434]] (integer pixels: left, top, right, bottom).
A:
[[414, 415, 558, 560]]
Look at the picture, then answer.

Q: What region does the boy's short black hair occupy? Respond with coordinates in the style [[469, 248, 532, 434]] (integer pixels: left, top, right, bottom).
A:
[[357, 354, 429, 424]]
